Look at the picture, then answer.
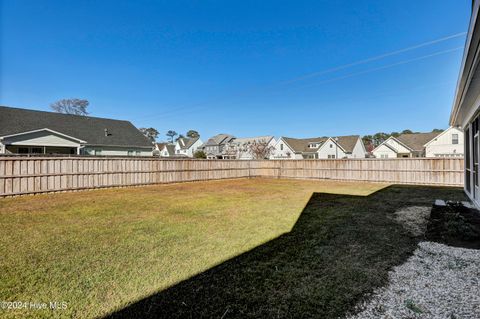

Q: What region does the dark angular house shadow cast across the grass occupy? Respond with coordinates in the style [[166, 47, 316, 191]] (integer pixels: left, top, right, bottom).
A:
[[105, 186, 465, 318]]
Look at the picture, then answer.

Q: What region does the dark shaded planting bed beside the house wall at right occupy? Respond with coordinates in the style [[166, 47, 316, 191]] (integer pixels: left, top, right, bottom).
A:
[[425, 203, 480, 249]]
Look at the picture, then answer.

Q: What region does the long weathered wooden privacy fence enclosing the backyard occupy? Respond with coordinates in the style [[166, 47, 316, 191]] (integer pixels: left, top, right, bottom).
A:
[[0, 157, 463, 196]]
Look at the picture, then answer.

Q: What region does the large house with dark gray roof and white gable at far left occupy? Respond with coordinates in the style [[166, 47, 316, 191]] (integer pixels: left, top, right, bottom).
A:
[[0, 106, 153, 156]]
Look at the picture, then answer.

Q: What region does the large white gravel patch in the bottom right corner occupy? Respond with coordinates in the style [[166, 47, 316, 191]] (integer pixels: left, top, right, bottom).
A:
[[348, 242, 480, 319]]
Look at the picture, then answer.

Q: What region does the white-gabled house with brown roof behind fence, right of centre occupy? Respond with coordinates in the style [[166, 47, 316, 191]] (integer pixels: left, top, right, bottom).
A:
[[271, 135, 366, 159]]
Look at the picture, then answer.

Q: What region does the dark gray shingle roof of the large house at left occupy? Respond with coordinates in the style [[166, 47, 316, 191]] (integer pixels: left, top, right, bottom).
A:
[[0, 106, 152, 147]]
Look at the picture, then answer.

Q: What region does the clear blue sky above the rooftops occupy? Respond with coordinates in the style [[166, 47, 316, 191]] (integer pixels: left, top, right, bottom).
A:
[[0, 0, 471, 140]]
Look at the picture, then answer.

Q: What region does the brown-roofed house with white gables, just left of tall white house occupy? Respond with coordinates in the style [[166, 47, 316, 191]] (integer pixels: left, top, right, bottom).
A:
[[372, 132, 441, 158]]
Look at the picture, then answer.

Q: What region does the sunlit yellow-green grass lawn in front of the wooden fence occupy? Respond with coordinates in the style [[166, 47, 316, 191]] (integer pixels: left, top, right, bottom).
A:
[[0, 179, 382, 318]]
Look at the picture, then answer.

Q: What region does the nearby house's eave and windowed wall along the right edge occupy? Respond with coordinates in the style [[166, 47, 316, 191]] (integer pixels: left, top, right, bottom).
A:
[[450, 0, 480, 207]]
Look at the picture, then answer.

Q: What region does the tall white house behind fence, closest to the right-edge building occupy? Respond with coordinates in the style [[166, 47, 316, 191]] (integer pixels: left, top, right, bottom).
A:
[[425, 126, 464, 157]]
